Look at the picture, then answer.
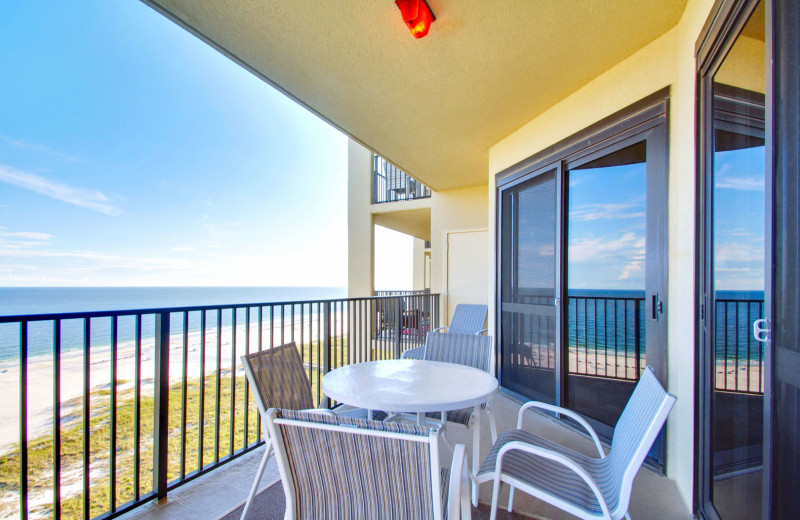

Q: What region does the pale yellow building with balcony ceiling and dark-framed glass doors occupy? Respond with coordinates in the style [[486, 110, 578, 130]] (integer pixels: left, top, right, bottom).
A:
[[136, 0, 800, 519]]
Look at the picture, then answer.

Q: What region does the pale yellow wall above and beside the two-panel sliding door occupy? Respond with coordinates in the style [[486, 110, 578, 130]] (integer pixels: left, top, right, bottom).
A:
[[486, 0, 713, 508]]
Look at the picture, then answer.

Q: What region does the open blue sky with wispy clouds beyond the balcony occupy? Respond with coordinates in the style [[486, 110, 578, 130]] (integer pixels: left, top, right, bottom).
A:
[[0, 0, 354, 286]]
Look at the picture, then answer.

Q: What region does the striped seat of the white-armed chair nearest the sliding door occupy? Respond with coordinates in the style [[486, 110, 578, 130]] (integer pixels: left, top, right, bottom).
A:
[[478, 429, 619, 515]]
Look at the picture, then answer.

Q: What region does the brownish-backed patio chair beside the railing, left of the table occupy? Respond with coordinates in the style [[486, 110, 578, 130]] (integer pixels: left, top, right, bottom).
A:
[[240, 342, 367, 520]]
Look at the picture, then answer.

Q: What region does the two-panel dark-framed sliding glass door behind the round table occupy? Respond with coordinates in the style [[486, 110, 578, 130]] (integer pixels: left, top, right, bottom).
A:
[[497, 98, 667, 462]]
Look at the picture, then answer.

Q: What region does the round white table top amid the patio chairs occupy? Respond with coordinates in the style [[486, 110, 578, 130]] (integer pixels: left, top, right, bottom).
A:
[[322, 359, 498, 412]]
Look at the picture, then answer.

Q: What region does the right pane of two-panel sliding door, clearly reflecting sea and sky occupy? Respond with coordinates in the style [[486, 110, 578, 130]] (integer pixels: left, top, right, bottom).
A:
[[566, 140, 647, 436]]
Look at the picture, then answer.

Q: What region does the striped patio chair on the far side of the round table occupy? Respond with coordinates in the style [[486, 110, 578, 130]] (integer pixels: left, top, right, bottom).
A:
[[425, 332, 497, 488]]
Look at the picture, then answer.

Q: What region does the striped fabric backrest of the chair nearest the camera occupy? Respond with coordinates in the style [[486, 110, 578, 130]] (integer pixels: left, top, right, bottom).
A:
[[278, 410, 447, 520]]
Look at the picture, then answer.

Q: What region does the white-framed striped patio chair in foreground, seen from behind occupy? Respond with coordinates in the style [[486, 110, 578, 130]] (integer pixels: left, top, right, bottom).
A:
[[266, 409, 471, 520]]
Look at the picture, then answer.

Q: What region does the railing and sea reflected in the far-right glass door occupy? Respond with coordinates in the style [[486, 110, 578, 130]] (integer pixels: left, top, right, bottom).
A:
[[714, 299, 764, 394]]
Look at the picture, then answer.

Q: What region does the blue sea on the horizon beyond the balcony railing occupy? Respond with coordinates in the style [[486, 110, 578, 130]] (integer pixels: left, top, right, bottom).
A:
[[0, 287, 347, 362]]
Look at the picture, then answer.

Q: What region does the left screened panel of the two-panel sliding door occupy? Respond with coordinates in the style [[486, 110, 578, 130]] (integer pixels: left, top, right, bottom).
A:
[[498, 168, 560, 403]]
